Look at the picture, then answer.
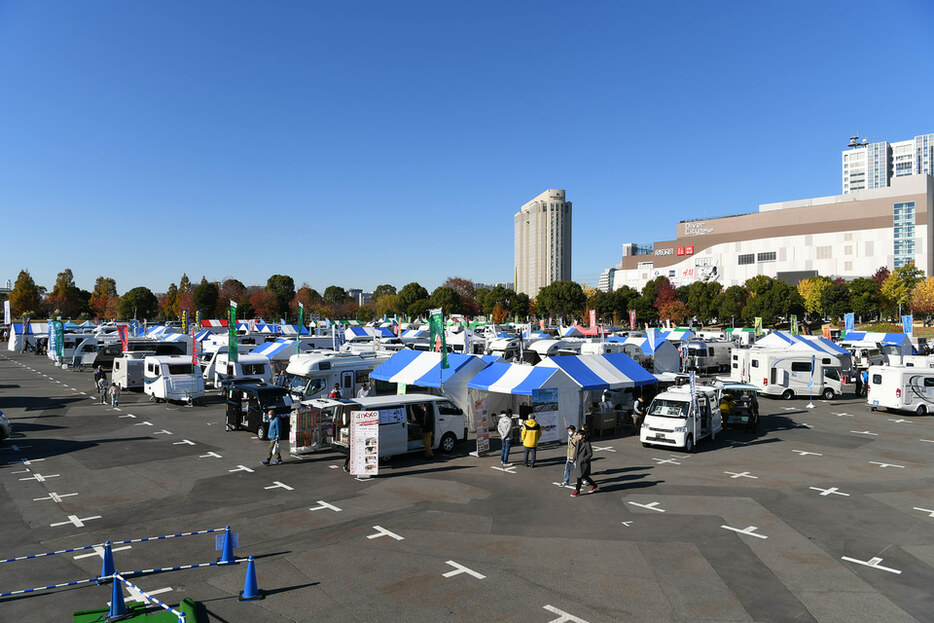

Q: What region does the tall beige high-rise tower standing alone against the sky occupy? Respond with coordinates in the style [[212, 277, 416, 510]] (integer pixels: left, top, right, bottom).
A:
[[514, 189, 571, 298]]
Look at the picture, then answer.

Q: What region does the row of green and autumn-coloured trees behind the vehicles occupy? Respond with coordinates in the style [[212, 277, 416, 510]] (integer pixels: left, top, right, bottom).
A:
[[9, 265, 934, 326]]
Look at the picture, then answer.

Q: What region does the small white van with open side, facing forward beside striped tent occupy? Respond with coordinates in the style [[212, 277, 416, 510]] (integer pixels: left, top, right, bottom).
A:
[[639, 385, 721, 452]]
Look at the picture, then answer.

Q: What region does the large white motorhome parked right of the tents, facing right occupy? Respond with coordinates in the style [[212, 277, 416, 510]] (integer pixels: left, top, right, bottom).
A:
[[731, 348, 851, 400]]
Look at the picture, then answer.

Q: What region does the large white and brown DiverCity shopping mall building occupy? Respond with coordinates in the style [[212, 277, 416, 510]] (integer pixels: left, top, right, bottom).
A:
[[599, 173, 934, 290]]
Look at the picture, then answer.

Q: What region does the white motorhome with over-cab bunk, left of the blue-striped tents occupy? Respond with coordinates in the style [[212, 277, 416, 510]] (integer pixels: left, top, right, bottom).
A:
[[285, 351, 391, 402]]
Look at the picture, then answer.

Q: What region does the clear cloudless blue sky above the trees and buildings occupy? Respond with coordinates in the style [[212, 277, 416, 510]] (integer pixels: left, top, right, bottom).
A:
[[0, 0, 934, 293]]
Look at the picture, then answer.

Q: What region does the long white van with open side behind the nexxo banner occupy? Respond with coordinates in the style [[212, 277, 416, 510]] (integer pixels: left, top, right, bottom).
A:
[[333, 394, 467, 458]]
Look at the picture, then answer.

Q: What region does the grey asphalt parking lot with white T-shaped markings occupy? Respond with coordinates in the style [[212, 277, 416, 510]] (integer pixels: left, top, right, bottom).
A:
[[0, 351, 934, 623]]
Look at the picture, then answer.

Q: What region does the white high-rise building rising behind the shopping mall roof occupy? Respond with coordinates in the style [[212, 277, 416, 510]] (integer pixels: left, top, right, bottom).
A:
[[842, 134, 934, 195]]
